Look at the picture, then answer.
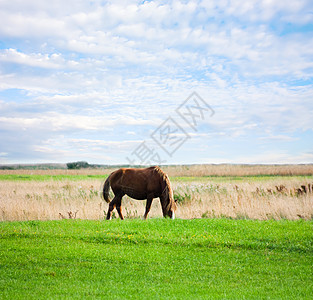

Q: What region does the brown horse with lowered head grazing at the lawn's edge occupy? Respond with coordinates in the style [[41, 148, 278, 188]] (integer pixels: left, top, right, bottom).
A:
[[103, 167, 176, 220]]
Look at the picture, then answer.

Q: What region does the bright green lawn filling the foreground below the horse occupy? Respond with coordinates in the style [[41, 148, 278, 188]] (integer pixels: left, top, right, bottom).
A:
[[0, 219, 313, 299]]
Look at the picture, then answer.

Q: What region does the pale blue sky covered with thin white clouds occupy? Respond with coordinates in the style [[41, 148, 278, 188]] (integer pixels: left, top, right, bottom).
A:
[[0, 0, 313, 165]]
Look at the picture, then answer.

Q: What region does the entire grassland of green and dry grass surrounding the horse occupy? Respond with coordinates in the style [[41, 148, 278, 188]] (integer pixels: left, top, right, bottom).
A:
[[0, 165, 313, 299]]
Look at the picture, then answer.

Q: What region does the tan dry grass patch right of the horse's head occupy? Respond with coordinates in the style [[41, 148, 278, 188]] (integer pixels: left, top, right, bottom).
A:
[[173, 178, 313, 220]]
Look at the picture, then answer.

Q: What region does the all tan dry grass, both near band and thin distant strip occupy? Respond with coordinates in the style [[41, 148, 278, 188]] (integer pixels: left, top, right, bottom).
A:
[[0, 165, 313, 221]]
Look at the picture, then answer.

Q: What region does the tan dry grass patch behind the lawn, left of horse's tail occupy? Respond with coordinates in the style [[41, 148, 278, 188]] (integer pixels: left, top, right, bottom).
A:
[[0, 180, 104, 221]]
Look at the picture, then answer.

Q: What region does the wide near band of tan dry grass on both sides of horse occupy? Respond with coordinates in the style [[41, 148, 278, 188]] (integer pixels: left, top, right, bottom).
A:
[[0, 178, 313, 221]]
